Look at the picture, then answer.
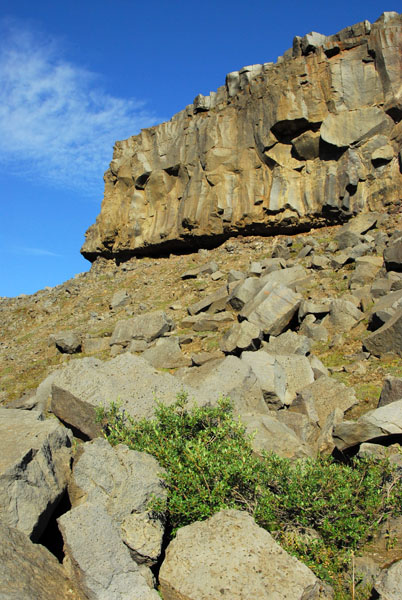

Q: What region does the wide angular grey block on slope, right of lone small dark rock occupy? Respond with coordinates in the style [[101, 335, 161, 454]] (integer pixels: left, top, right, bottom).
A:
[[110, 310, 174, 347]]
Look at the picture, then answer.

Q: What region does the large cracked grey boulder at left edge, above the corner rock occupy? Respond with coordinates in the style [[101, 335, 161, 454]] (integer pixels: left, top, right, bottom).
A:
[[0, 408, 73, 540]]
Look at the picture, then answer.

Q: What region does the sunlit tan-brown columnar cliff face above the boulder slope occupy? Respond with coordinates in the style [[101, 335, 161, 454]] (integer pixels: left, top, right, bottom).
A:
[[82, 13, 402, 261]]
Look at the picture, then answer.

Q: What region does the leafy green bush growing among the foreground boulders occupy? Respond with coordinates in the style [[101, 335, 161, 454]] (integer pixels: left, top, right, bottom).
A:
[[98, 395, 402, 597]]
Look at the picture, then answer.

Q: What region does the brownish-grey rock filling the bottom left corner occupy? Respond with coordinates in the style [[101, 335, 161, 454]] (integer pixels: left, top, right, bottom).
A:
[[0, 520, 87, 600]]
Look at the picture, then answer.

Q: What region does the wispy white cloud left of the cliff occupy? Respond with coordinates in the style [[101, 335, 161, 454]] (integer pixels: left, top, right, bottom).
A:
[[0, 21, 160, 193]]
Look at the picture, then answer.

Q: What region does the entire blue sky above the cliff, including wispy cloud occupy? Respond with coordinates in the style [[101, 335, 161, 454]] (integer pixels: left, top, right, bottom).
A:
[[0, 0, 400, 296]]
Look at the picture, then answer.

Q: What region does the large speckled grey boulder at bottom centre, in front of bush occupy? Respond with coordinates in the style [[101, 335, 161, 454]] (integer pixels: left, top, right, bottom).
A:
[[159, 510, 330, 600]]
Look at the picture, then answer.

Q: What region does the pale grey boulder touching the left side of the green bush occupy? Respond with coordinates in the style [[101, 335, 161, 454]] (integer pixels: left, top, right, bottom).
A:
[[69, 438, 166, 566]]
